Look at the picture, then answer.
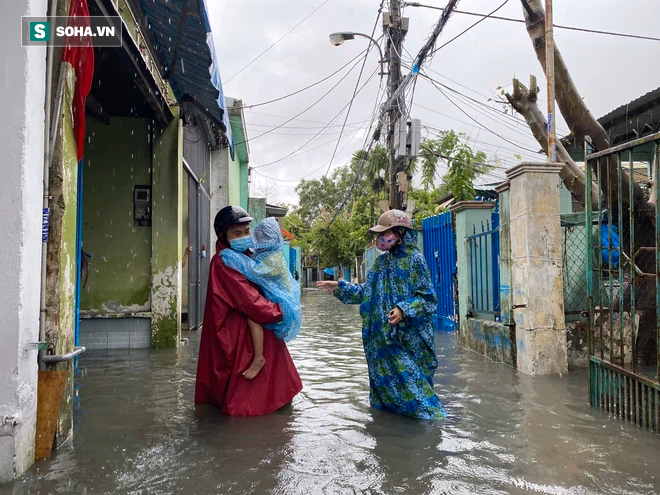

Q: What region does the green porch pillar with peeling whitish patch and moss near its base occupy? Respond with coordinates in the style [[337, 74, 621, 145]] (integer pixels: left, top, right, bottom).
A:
[[151, 108, 183, 348]]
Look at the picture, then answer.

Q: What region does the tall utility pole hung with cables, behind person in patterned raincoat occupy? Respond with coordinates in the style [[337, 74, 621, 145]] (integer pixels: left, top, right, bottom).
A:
[[386, 0, 405, 209]]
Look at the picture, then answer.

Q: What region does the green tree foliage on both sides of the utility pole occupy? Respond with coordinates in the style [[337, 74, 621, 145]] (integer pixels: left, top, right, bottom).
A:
[[285, 131, 488, 266]]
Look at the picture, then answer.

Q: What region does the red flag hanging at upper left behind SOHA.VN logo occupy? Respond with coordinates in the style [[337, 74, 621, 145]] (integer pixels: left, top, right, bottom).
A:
[[62, 0, 94, 161]]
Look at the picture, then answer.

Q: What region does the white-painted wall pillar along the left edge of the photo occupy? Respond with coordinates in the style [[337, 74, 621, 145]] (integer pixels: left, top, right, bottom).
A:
[[0, 0, 46, 483]]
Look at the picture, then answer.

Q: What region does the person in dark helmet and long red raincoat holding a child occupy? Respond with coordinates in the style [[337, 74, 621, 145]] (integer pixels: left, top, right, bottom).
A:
[[195, 206, 302, 416]]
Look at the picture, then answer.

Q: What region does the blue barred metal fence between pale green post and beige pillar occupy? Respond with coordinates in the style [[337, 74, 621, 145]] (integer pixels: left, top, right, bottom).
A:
[[465, 210, 501, 319]]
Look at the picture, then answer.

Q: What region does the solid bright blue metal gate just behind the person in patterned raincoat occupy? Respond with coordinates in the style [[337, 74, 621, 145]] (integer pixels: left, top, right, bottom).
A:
[[422, 212, 458, 331]]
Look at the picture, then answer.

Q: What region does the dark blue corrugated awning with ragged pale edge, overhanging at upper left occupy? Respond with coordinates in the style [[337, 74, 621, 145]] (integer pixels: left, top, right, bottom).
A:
[[140, 0, 234, 159]]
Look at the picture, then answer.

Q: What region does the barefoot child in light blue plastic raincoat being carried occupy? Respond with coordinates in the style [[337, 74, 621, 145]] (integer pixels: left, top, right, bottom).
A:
[[221, 218, 302, 380]]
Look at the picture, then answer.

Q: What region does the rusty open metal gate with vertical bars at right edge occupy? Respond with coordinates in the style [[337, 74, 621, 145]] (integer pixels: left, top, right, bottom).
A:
[[586, 133, 660, 433]]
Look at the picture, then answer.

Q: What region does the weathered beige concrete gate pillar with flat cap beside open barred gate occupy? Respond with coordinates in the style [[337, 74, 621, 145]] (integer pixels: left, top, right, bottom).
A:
[[507, 163, 568, 375]]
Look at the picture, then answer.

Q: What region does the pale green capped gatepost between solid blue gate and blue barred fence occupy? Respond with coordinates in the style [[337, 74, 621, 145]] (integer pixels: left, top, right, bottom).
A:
[[451, 201, 495, 338]]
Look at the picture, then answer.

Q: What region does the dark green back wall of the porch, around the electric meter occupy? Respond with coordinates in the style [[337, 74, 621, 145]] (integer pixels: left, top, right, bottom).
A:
[[81, 116, 152, 313]]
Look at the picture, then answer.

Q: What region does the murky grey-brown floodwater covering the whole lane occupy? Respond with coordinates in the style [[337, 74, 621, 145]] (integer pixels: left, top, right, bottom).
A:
[[0, 291, 660, 495]]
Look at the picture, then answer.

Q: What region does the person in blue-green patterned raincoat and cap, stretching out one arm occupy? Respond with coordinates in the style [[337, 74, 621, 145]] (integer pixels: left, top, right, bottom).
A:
[[318, 210, 446, 420]]
